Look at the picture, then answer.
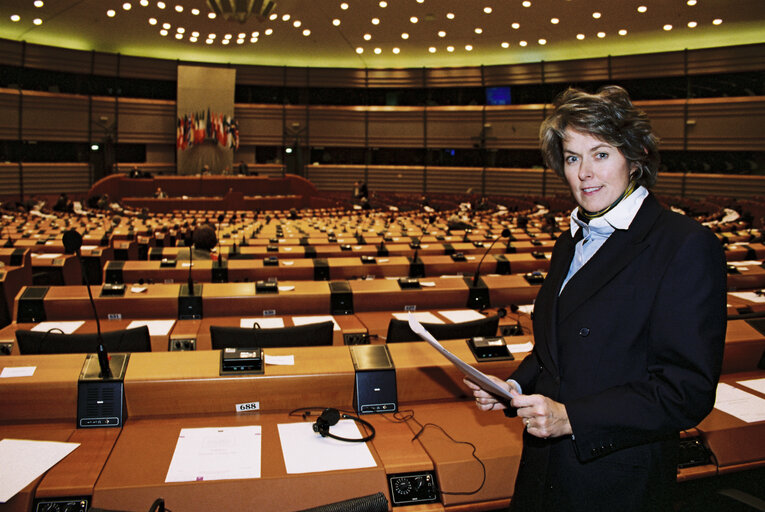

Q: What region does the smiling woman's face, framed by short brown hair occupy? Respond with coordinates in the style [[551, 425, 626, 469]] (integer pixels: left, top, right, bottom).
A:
[[563, 128, 630, 213]]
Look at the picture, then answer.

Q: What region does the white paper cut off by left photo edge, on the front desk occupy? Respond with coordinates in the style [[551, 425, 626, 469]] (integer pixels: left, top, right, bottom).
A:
[[0, 439, 80, 503]]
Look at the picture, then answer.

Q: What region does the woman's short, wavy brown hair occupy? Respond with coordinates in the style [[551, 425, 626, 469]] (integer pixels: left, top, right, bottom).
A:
[[539, 85, 659, 188]]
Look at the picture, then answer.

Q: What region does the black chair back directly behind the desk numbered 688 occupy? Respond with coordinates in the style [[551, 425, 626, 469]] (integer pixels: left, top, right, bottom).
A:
[[210, 320, 335, 350]]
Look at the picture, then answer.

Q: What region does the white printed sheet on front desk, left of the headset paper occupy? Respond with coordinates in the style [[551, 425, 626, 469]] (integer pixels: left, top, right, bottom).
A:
[[165, 425, 261, 482]]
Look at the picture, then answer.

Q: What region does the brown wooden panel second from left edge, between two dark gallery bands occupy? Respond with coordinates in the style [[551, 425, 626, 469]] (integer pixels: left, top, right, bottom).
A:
[[21, 91, 88, 142]]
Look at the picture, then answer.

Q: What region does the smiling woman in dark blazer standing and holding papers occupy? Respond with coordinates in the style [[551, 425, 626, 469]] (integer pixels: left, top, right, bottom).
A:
[[466, 87, 726, 512]]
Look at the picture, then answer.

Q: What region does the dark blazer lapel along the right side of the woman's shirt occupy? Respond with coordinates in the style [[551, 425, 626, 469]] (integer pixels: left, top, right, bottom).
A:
[[558, 194, 662, 321]]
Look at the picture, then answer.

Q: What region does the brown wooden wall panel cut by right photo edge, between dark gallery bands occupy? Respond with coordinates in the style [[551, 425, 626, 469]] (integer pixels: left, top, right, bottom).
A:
[[687, 97, 765, 151]]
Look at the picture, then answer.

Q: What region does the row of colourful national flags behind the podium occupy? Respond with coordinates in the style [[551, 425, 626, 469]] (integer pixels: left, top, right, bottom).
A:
[[175, 108, 239, 149]]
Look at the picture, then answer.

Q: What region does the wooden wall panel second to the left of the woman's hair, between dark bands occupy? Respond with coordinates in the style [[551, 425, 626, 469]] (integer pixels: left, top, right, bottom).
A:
[[427, 107, 483, 148]]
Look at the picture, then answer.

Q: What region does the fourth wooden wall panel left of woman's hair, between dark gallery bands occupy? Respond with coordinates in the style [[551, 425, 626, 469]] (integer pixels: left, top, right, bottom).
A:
[[310, 107, 366, 147]]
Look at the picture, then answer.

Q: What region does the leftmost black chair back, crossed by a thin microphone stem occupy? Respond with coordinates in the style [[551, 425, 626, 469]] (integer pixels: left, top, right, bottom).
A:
[[16, 325, 151, 354]]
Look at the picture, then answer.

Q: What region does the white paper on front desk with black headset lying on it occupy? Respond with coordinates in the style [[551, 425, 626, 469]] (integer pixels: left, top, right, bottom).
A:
[[278, 420, 377, 475]]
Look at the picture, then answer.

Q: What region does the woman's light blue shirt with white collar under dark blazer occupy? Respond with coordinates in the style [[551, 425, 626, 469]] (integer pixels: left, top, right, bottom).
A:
[[558, 186, 648, 294]]
